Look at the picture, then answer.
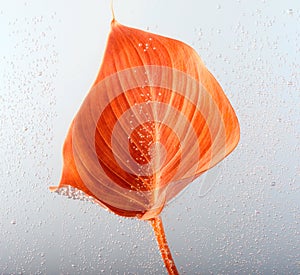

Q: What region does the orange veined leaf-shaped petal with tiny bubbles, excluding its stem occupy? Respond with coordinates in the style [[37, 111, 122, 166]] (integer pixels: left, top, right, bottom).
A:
[[50, 20, 239, 219]]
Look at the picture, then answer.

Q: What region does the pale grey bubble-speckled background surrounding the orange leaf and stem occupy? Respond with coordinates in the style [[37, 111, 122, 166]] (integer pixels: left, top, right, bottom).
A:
[[0, 0, 300, 274]]
